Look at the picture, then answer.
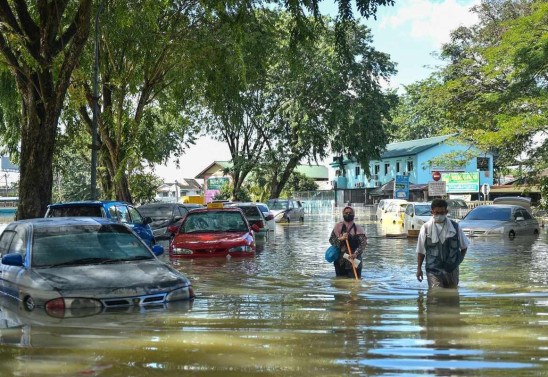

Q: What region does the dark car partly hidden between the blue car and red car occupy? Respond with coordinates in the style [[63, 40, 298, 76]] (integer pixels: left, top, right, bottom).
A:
[[139, 203, 203, 243]]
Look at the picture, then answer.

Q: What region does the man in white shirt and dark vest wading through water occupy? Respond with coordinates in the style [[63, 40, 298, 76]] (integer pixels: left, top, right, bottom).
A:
[[417, 199, 470, 288]]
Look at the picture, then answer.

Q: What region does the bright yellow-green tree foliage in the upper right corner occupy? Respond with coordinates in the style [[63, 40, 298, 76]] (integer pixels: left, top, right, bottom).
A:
[[434, 1, 548, 165]]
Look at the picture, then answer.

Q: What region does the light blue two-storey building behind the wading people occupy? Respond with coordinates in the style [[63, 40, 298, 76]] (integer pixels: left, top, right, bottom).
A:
[[330, 135, 493, 202]]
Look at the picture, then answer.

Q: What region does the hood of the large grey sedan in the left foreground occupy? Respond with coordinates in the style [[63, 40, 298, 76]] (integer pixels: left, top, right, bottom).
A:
[[34, 259, 190, 296]]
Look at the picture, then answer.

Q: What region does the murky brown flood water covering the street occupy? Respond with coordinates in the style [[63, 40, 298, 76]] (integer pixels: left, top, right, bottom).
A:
[[0, 213, 548, 377]]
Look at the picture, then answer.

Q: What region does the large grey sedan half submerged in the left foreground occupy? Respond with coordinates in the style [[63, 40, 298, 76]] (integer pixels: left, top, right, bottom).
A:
[[0, 217, 194, 318]]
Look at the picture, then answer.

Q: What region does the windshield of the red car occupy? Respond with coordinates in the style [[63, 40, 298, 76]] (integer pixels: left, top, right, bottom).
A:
[[181, 211, 249, 233]]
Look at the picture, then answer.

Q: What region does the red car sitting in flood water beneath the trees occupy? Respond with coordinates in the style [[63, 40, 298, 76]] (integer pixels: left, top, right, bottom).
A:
[[168, 208, 259, 258]]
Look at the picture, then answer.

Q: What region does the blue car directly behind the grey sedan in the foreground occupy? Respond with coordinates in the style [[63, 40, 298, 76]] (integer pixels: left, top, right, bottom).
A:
[[45, 200, 156, 247]]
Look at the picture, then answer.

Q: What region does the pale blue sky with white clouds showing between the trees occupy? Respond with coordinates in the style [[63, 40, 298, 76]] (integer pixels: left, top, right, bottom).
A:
[[155, 0, 480, 182]]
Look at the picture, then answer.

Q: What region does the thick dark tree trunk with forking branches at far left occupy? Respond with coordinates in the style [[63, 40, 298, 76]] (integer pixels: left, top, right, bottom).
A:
[[0, 0, 92, 219]]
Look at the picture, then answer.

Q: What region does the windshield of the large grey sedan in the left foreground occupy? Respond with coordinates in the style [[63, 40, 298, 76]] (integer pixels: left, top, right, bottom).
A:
[[31, 224, 154, 267]]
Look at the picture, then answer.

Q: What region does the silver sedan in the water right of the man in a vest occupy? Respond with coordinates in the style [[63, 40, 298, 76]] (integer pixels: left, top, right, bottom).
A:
[[459, 204, 540, 238]]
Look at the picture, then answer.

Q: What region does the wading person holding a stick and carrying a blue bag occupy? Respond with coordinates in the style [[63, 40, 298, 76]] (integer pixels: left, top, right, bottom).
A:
[[329, 205, 367, 278]]
